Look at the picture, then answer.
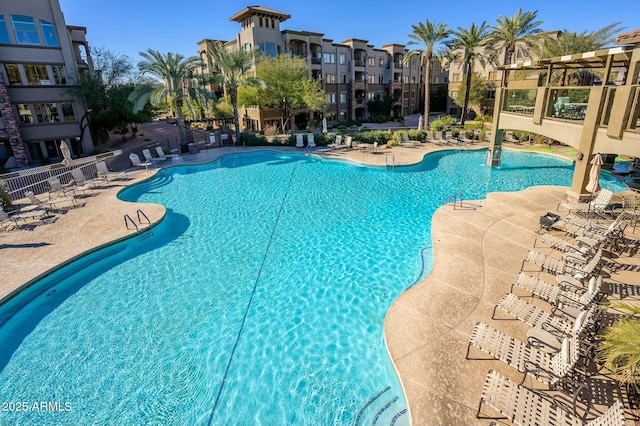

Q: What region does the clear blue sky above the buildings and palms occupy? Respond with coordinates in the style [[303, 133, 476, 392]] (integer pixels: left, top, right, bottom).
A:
[[60, 0, 640, 62]]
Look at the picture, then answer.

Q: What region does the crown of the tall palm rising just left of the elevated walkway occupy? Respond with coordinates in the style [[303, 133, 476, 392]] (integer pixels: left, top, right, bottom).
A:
[[491, 8, 543, 65]]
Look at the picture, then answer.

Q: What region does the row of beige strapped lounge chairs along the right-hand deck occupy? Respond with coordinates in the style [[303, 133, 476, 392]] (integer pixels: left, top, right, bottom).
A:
[[466, 199, 628, 426]]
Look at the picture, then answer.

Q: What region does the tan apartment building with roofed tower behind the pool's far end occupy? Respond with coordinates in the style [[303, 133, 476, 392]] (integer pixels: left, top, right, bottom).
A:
[[198, 6, 448, 130]]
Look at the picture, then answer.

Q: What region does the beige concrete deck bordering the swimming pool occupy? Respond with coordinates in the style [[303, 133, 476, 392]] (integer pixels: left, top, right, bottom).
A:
[[0, 144, 640, 425]]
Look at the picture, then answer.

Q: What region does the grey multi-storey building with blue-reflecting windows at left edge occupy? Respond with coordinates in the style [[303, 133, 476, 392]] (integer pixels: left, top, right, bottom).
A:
[[0, 0, 93, 167]]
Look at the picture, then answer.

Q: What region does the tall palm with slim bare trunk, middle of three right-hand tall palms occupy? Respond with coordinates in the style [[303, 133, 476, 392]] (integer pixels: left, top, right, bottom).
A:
[[448, 21, 496, 126]]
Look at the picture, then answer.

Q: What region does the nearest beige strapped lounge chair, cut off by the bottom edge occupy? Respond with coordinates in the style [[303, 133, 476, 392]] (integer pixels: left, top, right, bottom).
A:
[[476, 370, 626, 426]]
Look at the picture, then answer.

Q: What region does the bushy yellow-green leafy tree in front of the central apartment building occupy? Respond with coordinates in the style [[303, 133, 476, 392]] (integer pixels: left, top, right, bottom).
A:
[[243, 55, 326, 130]]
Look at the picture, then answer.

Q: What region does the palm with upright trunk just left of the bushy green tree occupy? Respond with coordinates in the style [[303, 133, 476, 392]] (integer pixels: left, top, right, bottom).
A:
[[207, 41, 261, 146]]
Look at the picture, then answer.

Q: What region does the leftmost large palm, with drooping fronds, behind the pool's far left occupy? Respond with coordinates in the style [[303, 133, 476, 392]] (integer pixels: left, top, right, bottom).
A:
[[129, 49, 200, 145]]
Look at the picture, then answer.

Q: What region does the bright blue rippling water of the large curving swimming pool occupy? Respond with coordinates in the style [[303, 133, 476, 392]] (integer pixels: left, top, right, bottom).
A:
[[0, 151, 624, 425]]
